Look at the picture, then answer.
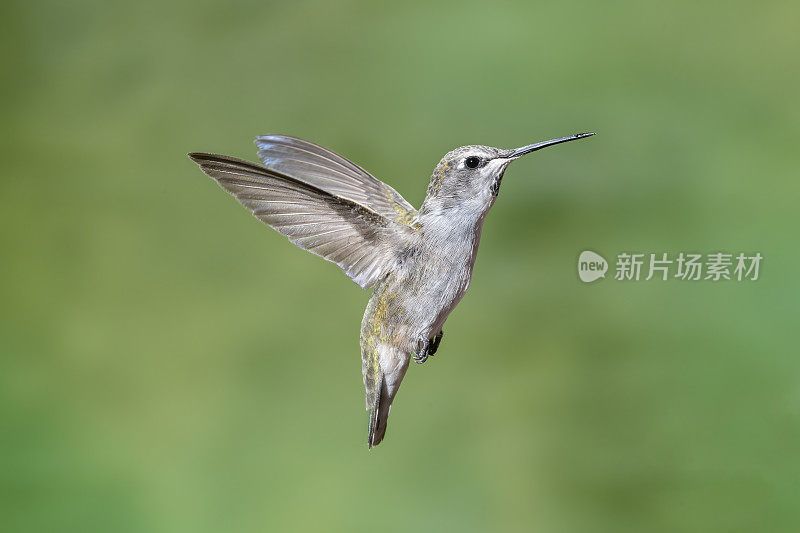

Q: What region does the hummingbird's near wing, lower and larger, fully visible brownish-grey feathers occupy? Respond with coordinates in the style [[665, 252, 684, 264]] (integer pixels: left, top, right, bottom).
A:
[[189, 153, 414, 288]]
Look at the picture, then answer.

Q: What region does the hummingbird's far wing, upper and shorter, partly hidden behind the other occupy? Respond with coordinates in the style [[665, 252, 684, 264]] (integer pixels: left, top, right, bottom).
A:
[[255, 135, 418, 229]]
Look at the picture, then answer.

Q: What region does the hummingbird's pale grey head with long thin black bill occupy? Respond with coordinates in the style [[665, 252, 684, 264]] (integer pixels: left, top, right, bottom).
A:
[[420, 133, 594, 219]]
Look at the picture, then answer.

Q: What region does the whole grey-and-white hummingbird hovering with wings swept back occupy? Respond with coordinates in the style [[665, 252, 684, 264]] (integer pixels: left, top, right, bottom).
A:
[[189, 133, 594, 448]]
